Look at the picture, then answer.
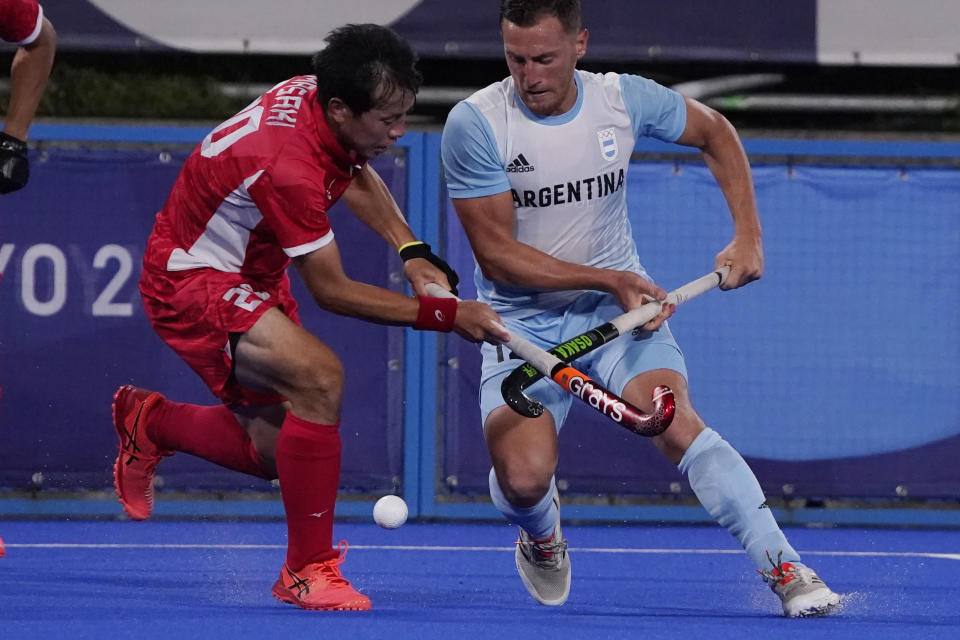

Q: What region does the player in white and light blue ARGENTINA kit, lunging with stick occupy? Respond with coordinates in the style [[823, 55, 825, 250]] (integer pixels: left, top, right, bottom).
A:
[[442, 0, 840, 616]]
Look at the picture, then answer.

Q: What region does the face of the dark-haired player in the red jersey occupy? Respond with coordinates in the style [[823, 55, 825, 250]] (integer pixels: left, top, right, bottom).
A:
[[327, 85, 414, 158]]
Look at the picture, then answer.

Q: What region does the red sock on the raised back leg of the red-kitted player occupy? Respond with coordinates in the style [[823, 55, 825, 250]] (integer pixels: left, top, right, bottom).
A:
[[147, 399, 277, 480]]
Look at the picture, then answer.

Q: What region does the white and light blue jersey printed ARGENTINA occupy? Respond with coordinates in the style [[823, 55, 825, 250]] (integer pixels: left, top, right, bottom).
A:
[[442, 71, 686, 316]]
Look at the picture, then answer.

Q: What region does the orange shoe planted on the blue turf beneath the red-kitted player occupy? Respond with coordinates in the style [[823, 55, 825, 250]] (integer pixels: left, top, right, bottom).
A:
[[273, 540, 370, 611]]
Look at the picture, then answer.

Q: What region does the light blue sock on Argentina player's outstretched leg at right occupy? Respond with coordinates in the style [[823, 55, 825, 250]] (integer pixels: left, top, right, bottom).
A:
[[678, 429, 800, 569]]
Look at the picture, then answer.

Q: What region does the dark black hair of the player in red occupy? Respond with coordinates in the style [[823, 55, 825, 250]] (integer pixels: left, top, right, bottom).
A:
[[313, 24, 423, 115]]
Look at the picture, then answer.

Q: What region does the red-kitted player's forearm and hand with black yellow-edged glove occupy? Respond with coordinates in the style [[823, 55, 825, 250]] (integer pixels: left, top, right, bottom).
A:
[[342, 164, 457, 295]]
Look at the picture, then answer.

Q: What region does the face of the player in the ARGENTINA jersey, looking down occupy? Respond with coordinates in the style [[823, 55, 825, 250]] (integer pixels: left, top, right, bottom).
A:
[[500, 16, 587, 116]]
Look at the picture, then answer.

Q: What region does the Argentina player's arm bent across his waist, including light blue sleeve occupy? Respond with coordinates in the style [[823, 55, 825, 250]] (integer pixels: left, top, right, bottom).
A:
[[441, 102, 667, 316]]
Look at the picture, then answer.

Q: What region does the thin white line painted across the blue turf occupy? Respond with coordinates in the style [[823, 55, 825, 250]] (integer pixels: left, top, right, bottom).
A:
[[6, 542, 960, 561]]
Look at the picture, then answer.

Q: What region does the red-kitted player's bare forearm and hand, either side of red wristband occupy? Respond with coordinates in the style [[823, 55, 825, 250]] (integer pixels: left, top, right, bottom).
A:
[[293, 236, 510, 344]]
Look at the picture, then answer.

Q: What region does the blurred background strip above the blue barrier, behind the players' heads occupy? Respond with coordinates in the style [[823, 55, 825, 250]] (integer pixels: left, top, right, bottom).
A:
[[0, 0, 960, 135]]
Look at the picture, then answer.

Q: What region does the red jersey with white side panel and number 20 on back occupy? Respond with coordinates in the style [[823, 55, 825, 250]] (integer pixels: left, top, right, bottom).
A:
[[144, 75, 365, 280]]
